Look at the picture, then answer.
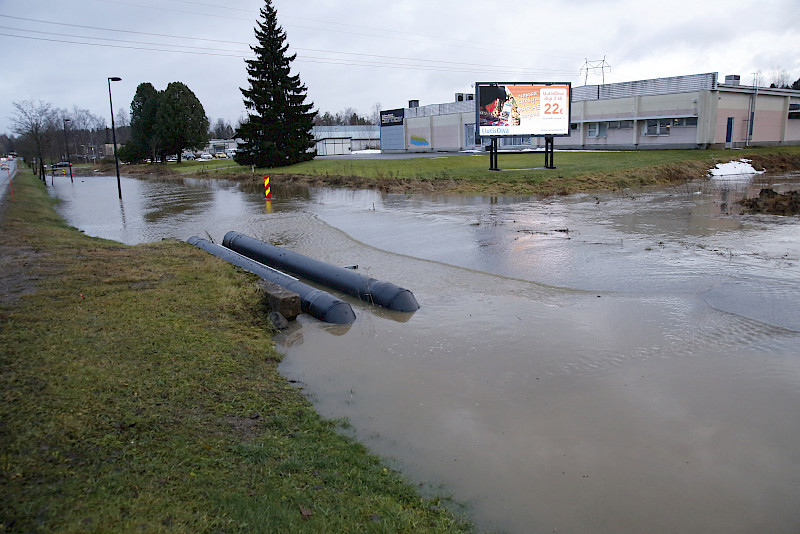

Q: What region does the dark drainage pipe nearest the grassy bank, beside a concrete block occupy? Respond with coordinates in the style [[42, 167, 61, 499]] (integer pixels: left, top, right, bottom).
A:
[[187, 236, 356, 324]]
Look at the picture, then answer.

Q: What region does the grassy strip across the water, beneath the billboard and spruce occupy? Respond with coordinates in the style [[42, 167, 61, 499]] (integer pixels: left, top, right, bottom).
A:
[[122, 147, 800, 195]]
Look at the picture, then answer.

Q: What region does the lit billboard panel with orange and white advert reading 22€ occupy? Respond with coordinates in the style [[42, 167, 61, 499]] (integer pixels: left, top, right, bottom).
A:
[[475, 82, 572, 137]]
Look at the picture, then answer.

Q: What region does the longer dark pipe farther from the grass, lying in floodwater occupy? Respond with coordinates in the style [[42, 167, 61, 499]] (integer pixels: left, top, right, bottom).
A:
[[222, 232, 419, 312]]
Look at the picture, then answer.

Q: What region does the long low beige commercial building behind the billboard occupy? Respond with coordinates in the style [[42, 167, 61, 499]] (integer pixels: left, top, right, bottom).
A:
[[380, 73, 800, 152]]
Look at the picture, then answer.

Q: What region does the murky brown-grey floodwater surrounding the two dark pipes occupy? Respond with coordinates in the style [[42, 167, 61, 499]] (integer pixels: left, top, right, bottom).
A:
[[48, 175, 800, 534]]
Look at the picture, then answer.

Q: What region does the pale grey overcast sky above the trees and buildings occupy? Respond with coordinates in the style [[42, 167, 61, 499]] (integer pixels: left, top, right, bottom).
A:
[[0, 0, 800, 134]]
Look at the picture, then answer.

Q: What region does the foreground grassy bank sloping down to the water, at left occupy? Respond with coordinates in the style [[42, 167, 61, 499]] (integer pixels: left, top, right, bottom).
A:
[[0, 172, 468, 533]]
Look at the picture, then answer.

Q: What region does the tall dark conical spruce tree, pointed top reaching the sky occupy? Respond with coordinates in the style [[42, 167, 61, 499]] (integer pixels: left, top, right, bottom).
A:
[[235, 0, 315, 167]]
